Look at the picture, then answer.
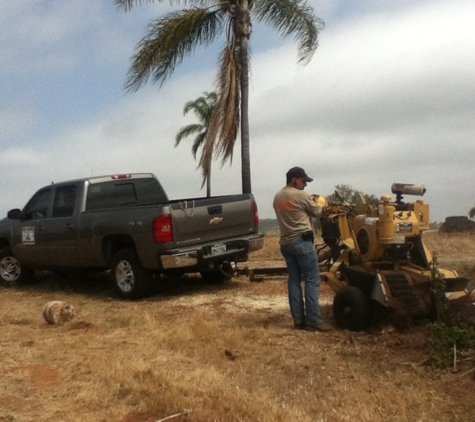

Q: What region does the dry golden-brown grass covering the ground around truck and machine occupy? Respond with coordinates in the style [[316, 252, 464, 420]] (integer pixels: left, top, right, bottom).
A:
[[0, 234, 475, 422]]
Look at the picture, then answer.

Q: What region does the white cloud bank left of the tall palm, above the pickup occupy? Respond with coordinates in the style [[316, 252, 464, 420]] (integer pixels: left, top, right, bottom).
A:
[[0, 73, 241, 215]]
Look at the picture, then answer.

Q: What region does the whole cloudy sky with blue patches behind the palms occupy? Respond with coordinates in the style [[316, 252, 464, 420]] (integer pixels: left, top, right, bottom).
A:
[[0, 0, 475, 222]]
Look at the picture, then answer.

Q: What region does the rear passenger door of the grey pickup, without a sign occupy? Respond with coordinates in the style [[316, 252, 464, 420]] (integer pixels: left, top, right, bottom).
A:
[[45, 184, 79, 267]]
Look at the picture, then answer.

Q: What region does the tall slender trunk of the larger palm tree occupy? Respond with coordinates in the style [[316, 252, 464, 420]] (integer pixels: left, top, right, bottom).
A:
[[239, 4, 252, 193]]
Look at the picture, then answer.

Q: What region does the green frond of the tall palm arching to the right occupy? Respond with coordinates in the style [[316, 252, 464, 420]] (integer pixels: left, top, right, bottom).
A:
[[252, 0, 325, 64]]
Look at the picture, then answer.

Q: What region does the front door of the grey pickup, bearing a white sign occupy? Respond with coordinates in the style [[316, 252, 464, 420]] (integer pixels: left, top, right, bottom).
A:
[[14, 187, 53, 266]]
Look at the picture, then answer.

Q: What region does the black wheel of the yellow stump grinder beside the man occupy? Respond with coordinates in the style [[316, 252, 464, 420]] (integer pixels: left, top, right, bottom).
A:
[[333, 286, 371, 331]]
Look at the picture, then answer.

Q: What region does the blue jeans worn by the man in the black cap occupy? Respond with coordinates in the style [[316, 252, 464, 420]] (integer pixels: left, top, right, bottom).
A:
[[280, 239, 321, 325]]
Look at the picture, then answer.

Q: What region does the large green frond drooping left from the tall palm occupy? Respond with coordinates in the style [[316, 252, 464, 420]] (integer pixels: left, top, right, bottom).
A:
[[125, 9, 222, 91]]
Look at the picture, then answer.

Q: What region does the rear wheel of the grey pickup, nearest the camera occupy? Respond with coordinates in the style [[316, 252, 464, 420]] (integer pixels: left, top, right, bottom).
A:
[[111, 249, 153, 300]]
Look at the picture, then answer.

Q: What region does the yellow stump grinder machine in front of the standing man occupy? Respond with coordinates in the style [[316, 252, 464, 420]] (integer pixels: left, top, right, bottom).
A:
[[319, 183, 473, 331]]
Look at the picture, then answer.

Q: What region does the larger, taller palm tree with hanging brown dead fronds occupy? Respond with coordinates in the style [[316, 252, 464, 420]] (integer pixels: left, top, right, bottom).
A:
[[115, 0, 324, 193]]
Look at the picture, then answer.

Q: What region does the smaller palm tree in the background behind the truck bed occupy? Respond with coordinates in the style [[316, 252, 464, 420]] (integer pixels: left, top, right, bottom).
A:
[[175, 92, 218, 197]]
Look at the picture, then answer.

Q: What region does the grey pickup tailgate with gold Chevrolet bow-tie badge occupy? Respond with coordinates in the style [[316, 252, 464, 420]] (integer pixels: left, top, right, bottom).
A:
[[170, 195, 258, 246]]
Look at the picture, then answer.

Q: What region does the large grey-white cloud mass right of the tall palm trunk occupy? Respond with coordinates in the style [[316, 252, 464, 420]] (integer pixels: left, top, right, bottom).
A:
[[251, 2, 475, 220]]
